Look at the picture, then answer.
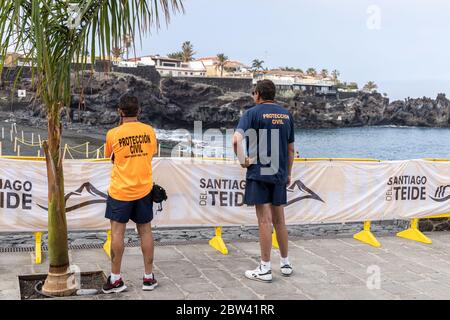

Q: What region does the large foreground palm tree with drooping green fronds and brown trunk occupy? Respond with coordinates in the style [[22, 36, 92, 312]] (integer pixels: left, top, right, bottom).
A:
[[0, 0, 184, 296]]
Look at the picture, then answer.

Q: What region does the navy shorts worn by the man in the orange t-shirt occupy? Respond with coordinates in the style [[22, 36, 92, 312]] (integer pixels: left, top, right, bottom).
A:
[[105, 192, 153, 224]]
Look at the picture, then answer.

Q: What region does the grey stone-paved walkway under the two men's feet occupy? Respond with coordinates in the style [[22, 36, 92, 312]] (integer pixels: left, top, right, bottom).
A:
[[0, 232, 450, 300]]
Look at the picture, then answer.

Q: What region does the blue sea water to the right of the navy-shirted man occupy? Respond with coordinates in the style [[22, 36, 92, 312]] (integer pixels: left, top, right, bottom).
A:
[[296, 126, 450, 160]]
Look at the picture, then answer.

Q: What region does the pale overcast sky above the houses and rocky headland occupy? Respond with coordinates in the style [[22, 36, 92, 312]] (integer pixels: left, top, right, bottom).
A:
[[138, 0, 450, 99]]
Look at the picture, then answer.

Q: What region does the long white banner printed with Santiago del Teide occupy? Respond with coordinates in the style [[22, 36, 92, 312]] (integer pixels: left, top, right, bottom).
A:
[[0, 158, 450, 232]]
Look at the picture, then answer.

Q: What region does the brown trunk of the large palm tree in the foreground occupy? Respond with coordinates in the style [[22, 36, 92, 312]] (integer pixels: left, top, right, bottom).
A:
[[43, 102, 76, 296]]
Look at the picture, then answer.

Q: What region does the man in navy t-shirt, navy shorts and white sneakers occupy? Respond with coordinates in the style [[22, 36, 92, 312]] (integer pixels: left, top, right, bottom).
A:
[[233, 80, 295, 282]]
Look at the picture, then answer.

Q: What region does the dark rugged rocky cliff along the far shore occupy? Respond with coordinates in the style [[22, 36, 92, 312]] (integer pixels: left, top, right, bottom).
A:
[[0, 73, 450, 129]]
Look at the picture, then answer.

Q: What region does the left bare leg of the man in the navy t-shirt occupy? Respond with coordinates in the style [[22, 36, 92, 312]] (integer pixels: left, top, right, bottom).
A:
[[256, 204, 273, 262]]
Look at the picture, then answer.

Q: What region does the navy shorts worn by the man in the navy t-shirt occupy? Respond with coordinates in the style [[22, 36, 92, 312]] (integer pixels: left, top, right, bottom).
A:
[[244, 180, 287, 206]]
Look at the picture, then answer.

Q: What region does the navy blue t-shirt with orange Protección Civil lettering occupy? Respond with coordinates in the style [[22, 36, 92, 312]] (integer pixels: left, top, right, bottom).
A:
[[237, 104, 295, 184]]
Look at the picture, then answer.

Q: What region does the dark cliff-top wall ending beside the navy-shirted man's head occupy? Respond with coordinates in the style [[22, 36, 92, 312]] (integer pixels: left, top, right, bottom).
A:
[[168, 77, 253, 93]]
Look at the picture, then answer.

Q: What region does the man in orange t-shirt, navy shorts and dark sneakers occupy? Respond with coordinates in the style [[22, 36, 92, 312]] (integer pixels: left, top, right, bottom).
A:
[[103, 94, 158, 293]]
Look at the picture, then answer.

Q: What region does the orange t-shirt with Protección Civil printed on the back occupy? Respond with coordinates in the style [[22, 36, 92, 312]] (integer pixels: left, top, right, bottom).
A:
[[105, 122, 157, 201]]
